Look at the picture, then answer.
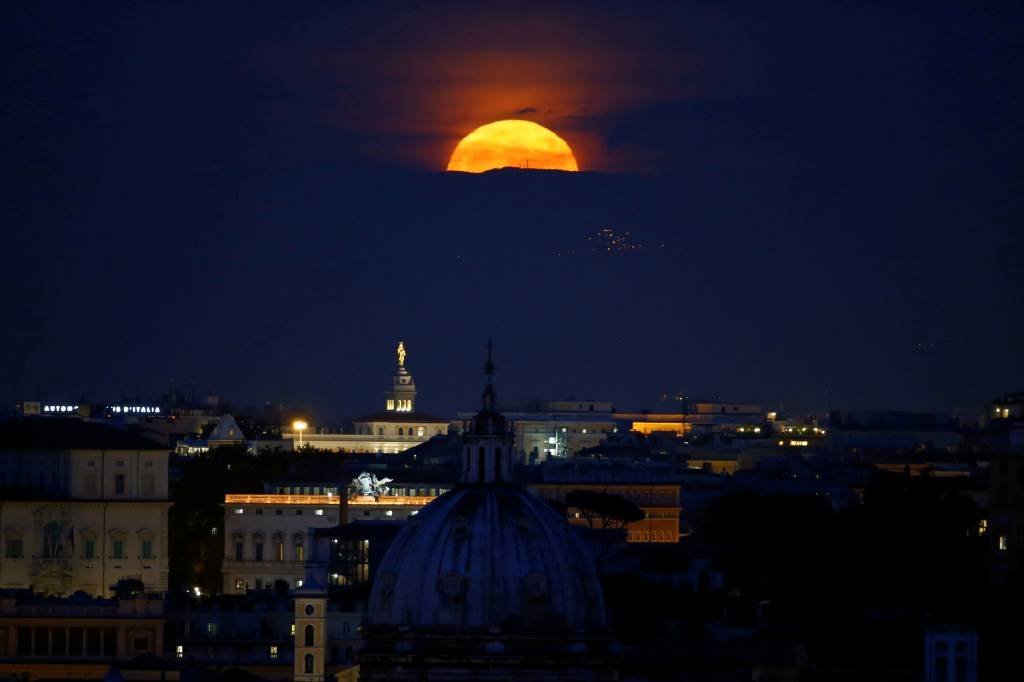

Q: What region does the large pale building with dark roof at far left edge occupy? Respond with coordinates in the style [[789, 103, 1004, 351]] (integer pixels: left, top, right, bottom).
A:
[[0, 418, 171, 596]]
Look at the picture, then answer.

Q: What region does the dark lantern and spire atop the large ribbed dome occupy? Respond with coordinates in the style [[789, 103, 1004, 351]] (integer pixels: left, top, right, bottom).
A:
[[461, 339, 515, 484]]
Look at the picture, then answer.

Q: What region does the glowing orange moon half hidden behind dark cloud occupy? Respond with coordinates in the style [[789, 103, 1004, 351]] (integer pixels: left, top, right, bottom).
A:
[[447, 119, 580, 173]]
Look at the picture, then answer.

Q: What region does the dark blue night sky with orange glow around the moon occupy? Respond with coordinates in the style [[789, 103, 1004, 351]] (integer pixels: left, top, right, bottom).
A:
[[0, 2, 1024, 421]]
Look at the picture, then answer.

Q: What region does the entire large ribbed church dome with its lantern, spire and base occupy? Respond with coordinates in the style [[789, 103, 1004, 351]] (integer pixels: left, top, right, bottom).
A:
[[358, 342, 614, 682]]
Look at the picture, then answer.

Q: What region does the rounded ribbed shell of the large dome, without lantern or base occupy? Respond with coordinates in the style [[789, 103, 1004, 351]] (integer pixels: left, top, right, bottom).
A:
[[368, 484, 607, 637]]
